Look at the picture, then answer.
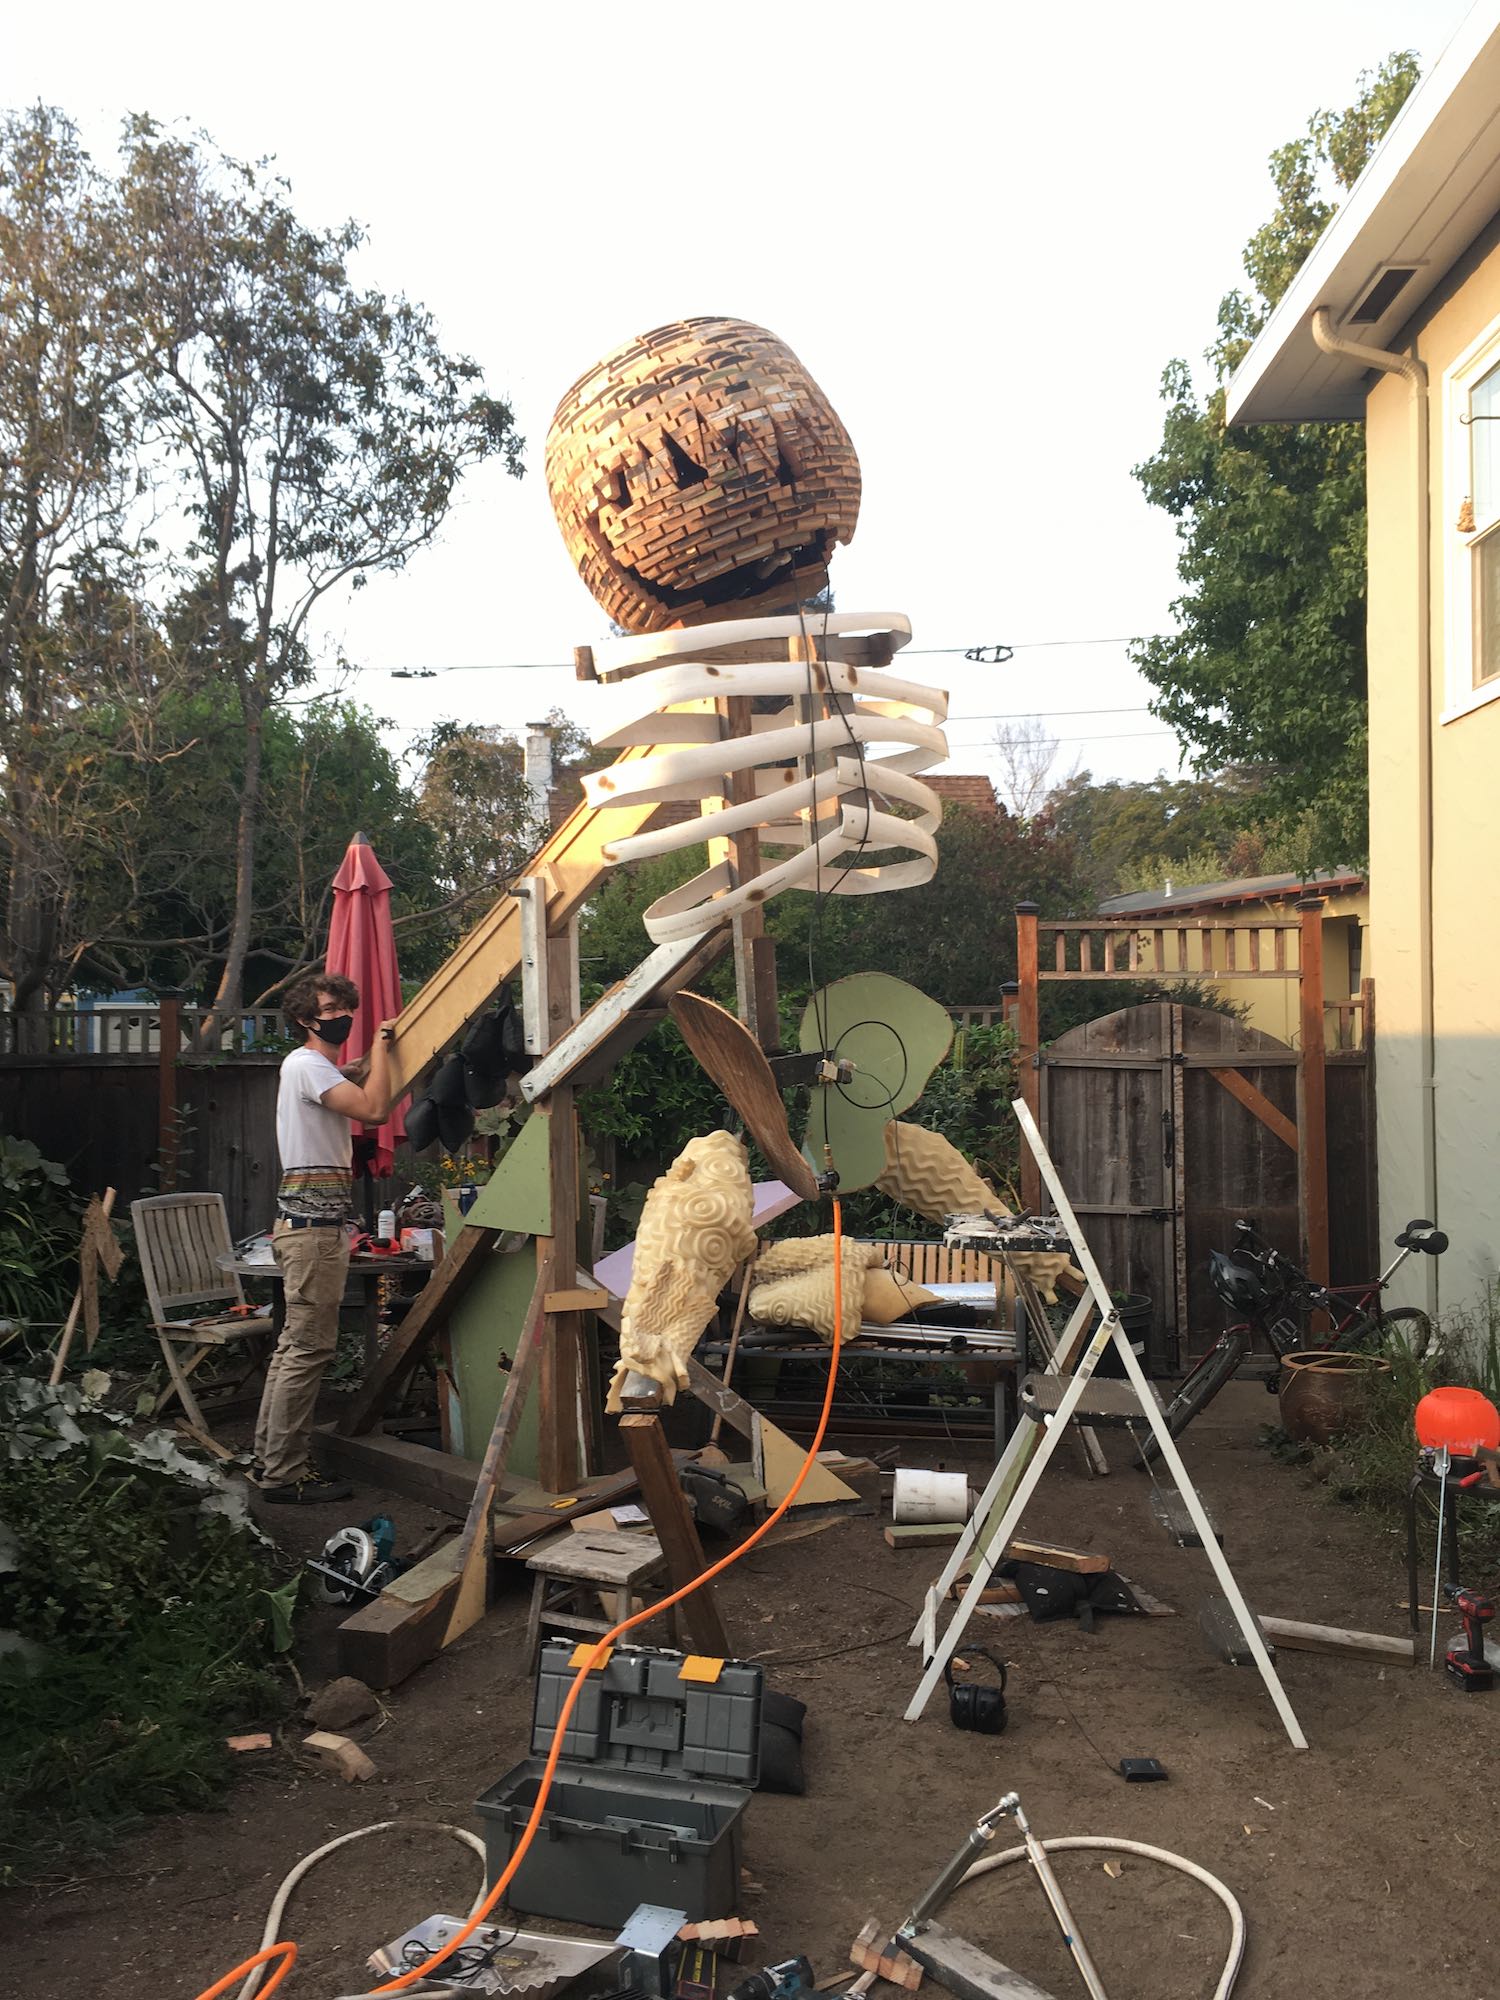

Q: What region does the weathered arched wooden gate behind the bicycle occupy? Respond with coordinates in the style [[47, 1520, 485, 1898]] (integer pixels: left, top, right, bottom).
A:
[[1038, 1000, 1374, 1374]]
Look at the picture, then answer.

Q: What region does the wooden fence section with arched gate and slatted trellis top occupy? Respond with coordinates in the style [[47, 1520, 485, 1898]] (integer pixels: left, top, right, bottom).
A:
[[1016, 898, 1378, 1370]]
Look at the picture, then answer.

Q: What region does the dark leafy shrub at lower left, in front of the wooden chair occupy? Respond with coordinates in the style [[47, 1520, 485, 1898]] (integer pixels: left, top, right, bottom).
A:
[[0, 1374, 300, 1884]]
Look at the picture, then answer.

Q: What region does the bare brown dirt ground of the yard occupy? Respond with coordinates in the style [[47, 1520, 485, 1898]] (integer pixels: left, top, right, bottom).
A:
[[0, 1384, 1500, 2000]]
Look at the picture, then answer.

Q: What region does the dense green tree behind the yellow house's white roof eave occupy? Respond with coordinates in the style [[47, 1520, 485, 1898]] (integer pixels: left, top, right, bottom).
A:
[[1132, 52, 1418, 864]]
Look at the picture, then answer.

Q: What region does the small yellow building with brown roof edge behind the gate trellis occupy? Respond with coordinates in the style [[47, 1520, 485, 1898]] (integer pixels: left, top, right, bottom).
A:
[[1098, 868, 1370, 1050]]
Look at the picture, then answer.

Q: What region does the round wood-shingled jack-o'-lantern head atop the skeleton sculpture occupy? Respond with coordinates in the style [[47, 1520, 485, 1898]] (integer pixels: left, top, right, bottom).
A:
[[546, 318, 860, 632]]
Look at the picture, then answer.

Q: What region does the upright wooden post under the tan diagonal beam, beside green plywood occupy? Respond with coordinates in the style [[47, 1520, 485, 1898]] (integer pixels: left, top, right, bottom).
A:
[[536, 926, 584, 1494]]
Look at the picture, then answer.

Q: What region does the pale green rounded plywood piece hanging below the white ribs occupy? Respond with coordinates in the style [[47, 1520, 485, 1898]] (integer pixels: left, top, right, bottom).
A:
[[798, 972, 954, 1194]]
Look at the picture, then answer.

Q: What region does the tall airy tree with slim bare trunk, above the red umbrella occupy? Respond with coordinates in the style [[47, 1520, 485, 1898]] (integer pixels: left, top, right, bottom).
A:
[[122, 118, 522, 1032]]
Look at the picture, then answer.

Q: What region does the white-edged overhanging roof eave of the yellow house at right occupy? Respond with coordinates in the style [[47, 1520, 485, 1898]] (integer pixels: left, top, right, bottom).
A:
[[1224, 0, 1500, 424]]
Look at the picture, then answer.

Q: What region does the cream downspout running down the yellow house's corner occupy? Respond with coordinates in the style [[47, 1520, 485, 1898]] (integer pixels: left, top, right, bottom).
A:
[[1312, 306, 1438, 1314]]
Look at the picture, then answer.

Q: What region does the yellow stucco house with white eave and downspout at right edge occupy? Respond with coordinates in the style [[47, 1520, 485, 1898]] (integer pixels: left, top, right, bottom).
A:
[[1228, 0, 1500, 1308]]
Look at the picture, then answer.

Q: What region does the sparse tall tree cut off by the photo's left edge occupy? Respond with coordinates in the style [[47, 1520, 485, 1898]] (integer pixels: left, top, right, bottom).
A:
[[0, 106, 148, 1024]]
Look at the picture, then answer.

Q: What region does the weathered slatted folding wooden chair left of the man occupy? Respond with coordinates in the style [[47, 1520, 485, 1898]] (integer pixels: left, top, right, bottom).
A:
[[130, 1194, 274, 1430]]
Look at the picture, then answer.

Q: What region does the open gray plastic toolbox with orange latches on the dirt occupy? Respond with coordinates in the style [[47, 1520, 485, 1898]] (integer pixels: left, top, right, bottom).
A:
[[478, 1640, 764, 1928]]
